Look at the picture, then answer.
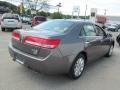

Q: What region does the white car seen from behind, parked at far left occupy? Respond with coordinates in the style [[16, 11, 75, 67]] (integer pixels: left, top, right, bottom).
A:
[[1, 13, 22, 31]]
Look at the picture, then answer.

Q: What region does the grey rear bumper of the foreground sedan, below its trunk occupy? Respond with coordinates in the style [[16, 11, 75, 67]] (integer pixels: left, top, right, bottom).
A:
[[9, 44, 69, 74]]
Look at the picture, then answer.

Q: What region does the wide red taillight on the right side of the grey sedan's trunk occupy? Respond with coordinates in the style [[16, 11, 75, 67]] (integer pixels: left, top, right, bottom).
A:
[[24, 36, 60, 49]]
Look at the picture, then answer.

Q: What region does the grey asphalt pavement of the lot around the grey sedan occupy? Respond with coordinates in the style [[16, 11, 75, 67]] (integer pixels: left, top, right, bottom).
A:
[[0, 25, 120, 90]]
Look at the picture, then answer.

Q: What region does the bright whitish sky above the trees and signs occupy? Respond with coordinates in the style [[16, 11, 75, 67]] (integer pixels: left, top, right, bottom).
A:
[[2, 0, 120, 16]]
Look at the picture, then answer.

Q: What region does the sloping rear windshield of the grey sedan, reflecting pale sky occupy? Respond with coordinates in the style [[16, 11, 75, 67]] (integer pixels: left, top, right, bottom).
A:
[[33, 20, 73, 33]]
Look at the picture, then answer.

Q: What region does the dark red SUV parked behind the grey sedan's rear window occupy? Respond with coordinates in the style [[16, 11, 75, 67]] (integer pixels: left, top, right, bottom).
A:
[[32, 16, 47, 26]]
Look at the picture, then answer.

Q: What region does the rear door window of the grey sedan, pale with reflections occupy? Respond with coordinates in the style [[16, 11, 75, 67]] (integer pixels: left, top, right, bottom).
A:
[[83, 24, 96, 36]]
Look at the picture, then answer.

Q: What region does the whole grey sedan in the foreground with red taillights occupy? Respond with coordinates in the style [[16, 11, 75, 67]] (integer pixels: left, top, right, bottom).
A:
[[9, 20, 114, 79]]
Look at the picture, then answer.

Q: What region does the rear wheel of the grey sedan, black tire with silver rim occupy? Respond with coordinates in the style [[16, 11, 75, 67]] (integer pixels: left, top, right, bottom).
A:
[[69, 54, 85, 80]]
